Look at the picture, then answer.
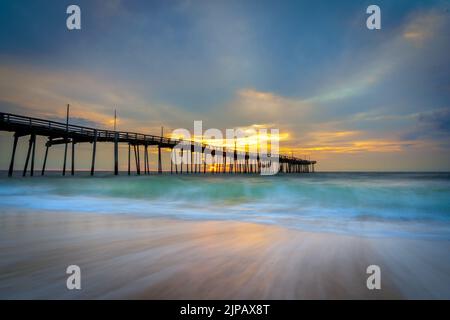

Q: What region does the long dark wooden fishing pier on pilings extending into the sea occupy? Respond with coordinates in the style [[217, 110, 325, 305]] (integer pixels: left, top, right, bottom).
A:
[[0, 112, 316, 176]]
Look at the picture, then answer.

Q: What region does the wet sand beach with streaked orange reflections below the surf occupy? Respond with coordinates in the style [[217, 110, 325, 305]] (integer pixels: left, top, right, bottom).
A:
[[0, 211, 450, 299]]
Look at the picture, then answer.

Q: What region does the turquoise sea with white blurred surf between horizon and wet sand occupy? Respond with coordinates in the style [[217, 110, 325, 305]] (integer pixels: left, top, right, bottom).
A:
[[0, 173, 450, 239]]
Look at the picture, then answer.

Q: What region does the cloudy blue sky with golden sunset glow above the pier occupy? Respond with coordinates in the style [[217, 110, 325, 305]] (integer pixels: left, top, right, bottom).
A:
[[0, 0, 450, 171]]
